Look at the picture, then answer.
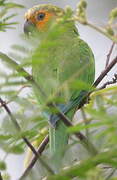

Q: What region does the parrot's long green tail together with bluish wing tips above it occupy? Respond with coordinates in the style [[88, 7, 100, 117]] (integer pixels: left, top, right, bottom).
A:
[[49, 91, 86, 171]]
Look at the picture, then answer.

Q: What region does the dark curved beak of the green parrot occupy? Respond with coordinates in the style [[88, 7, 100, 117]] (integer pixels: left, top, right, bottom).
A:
[[24, 20, 35, 35]]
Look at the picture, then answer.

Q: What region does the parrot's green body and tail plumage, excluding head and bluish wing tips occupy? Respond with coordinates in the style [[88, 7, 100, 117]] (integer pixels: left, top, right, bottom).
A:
[[29, 3, 95, 170]]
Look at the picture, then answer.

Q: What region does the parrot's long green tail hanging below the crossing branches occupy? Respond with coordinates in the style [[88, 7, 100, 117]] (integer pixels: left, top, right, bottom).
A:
[[49, 107, 74, 172]]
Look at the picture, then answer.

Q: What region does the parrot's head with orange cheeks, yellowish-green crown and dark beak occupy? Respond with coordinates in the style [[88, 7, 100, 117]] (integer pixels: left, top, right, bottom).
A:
[[24, 4, 65, 34]]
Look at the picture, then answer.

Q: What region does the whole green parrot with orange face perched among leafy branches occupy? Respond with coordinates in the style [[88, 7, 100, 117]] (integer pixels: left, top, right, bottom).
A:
[[24, 4, 95, 170]]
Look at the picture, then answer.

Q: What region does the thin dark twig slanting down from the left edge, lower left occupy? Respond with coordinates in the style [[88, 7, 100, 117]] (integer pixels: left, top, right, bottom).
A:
[[0, 98, 54, 174]]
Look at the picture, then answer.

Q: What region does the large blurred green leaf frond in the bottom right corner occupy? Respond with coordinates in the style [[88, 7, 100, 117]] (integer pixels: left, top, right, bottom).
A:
[[47, 149, 117, 180]]
